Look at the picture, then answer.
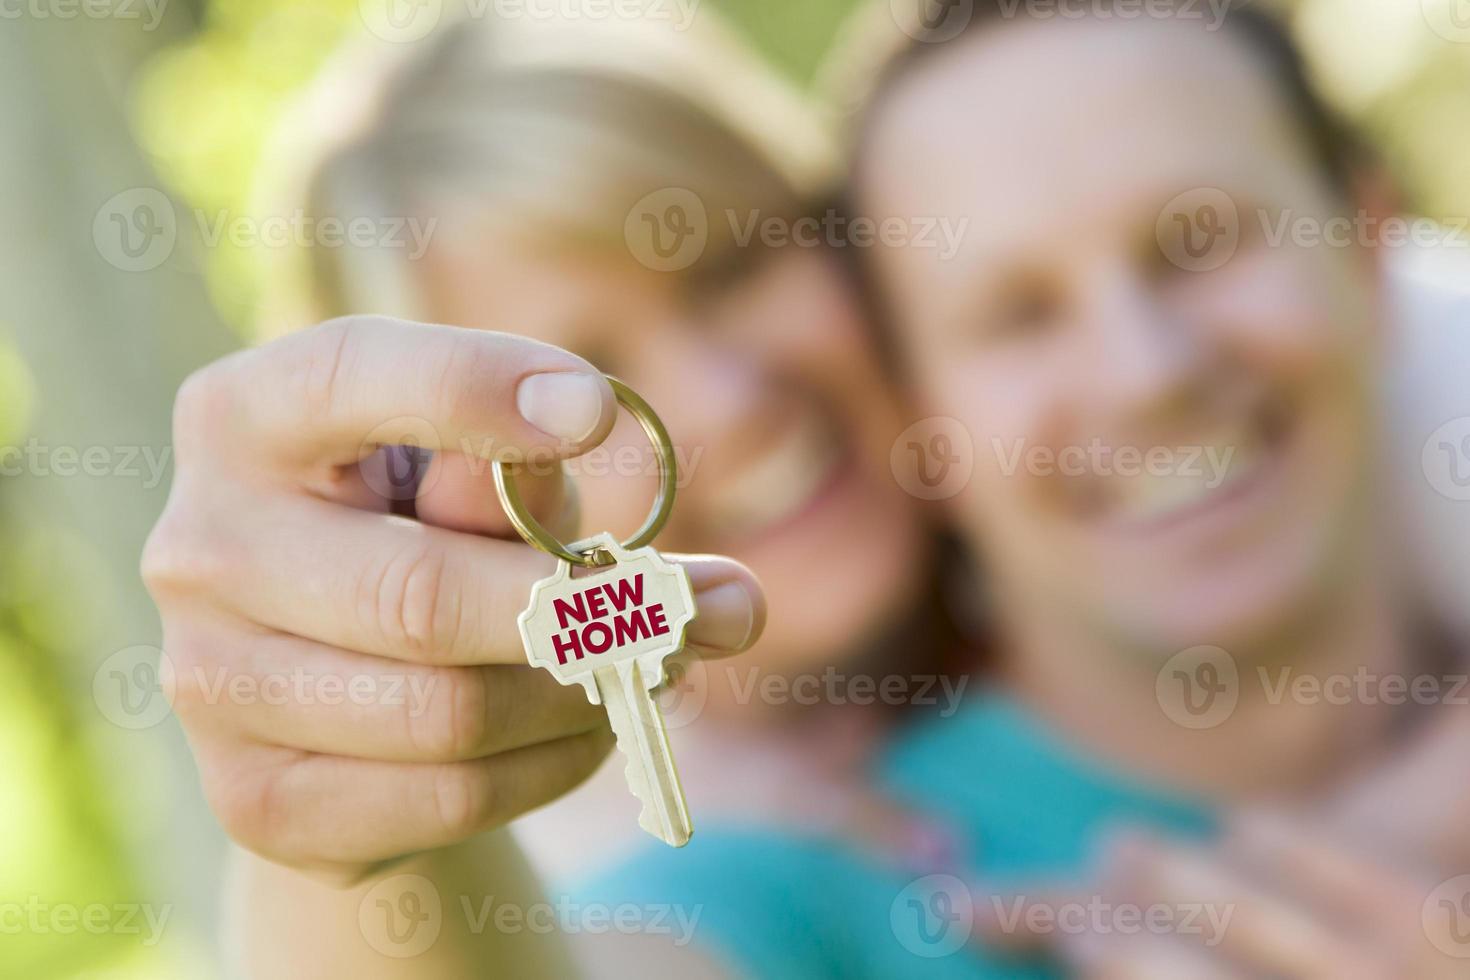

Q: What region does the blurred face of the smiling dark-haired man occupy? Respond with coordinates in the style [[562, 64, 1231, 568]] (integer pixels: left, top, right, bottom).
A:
[[858, 21, 1376, 652]]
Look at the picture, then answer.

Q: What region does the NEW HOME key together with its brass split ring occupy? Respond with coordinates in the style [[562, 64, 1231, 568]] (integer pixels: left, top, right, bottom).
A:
[[494, 376, 695, 846]]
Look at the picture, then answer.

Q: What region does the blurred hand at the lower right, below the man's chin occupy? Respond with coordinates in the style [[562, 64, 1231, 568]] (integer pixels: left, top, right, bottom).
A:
[[976, 815, 1470, 980]]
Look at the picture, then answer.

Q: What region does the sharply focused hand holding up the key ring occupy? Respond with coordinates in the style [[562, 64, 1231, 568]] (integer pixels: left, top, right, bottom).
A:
[[143, 317, 764, 883]]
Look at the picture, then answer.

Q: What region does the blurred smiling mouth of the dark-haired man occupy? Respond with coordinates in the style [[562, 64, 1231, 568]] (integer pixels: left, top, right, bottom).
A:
[[1076, 398, 1295, 533]]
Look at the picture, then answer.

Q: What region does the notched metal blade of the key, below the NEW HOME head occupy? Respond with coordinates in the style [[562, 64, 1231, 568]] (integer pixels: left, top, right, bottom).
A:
[[594, 660, 694, 848]]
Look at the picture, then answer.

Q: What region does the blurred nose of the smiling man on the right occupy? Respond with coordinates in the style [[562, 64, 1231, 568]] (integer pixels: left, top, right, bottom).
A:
[[1083, 262, 1208, 416]]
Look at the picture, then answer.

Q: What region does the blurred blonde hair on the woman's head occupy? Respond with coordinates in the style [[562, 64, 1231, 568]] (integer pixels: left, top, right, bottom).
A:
[[262, 9, 833, 335]]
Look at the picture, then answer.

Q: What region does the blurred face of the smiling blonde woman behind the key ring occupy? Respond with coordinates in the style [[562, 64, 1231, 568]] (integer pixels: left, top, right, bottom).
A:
[[425, 228, 925, 671]]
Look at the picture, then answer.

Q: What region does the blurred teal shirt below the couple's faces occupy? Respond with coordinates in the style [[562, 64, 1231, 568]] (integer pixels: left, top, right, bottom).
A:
[[570, 695, 1213, 980]]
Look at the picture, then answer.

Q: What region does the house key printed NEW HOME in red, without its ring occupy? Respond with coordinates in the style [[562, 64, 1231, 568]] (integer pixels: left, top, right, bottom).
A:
[[517, 533, 694, 848]]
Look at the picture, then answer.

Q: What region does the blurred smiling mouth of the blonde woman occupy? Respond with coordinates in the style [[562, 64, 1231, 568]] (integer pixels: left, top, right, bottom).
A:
[[704, 413, 851, 541]]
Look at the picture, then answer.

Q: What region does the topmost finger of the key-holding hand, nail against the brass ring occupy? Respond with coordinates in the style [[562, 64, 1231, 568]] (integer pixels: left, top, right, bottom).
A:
[[175, 316, 616, 467]]
